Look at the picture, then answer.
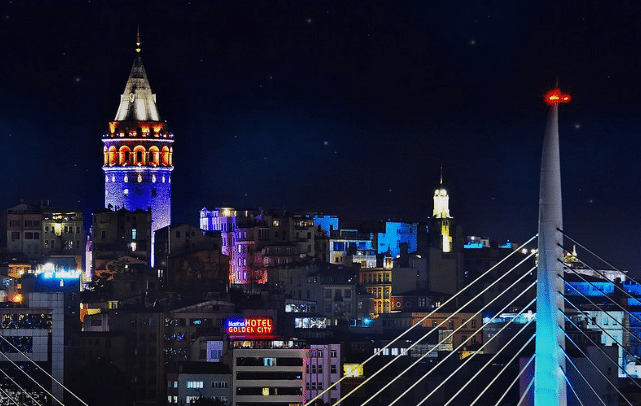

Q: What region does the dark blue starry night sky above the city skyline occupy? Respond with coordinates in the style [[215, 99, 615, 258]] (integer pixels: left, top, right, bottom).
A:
[[0, 0, 641, 272]]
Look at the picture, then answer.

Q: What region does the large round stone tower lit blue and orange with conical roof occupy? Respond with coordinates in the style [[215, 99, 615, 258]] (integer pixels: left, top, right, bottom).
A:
[[102, 35, 174, 266]]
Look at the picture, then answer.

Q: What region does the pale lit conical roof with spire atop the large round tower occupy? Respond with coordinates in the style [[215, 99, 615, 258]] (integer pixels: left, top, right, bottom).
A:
[[115, 37, 160, 121]]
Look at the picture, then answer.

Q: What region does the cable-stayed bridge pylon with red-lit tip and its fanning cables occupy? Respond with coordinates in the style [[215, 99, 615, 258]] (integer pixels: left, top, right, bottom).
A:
[[306, 89, 641, 406]]
